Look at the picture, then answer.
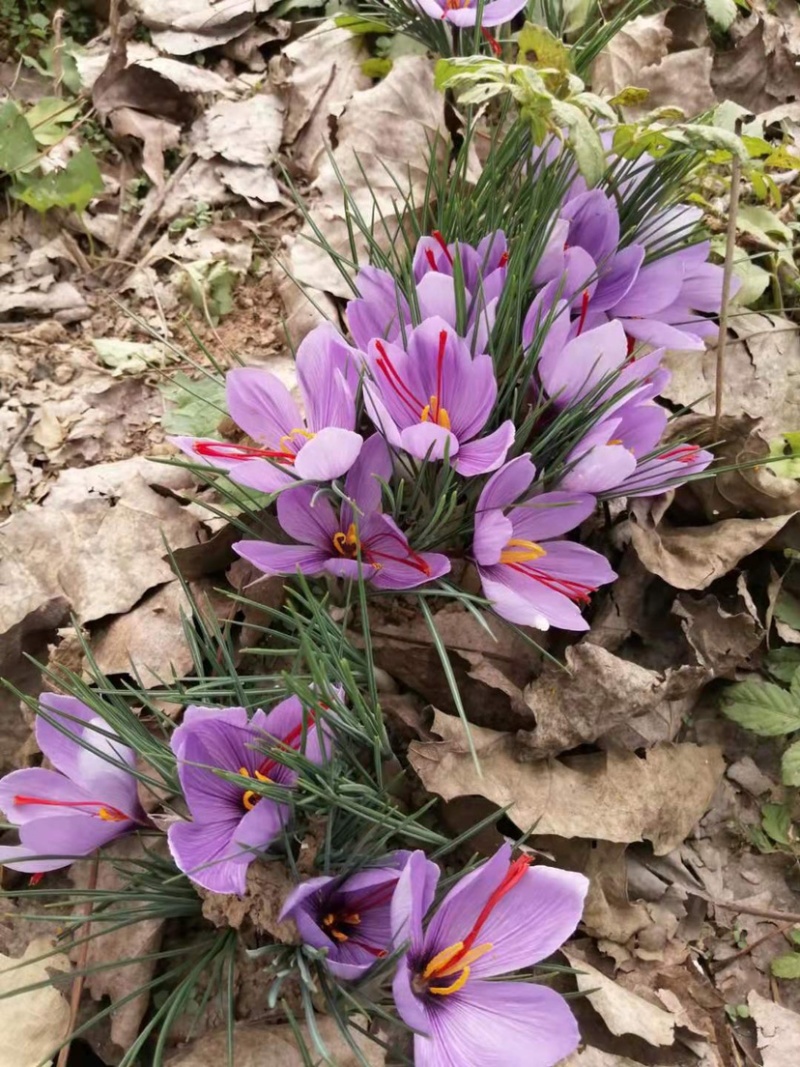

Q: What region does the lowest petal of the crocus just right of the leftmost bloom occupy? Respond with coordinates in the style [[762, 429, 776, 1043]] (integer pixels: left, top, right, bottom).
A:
[[166, 822, 247, 896]]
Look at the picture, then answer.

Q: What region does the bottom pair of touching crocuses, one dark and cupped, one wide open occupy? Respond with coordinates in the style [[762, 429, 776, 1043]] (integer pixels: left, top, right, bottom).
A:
[[283, 845, 589, 1067]]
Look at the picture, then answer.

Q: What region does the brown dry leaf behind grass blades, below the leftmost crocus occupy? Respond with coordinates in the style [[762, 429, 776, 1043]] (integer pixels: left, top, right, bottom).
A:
[[69, 837, 167, 1049]]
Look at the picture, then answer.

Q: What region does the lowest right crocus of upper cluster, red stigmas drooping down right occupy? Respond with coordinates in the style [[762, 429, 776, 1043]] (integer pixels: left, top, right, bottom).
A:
[[473, 456, 617, 630]]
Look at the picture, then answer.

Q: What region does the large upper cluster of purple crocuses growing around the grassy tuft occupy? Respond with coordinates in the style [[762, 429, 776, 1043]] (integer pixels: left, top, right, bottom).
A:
[[175, 179, 722, 630]]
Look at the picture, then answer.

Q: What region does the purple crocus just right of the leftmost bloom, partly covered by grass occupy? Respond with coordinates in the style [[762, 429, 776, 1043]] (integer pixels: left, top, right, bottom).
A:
[[167, 697, 323, 895]]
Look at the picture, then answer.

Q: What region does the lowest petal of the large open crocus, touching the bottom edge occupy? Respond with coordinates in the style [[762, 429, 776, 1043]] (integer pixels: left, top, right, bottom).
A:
[[414, 978, 580, 1067]]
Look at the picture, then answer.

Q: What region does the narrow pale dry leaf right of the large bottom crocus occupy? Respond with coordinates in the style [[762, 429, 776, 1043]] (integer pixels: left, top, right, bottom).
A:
[[561, 945, 675, 1046]]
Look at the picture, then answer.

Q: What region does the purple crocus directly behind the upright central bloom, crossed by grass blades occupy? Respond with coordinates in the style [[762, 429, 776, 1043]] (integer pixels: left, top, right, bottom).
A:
[[347, 229, 508, 352]]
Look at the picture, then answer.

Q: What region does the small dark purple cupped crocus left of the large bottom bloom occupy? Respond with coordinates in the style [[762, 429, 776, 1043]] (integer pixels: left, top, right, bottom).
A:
[[281, 851, 437, 981]]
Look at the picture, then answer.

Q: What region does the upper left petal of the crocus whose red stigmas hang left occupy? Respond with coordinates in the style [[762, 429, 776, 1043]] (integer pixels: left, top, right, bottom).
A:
[[225, 367, 304, 447]]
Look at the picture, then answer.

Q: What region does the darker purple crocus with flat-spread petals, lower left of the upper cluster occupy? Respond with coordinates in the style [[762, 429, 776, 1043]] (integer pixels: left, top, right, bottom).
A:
[[234, 433, 450, 589]]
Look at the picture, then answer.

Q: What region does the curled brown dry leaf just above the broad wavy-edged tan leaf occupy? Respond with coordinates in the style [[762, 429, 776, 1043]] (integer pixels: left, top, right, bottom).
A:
[[518, 643, 698, 759]]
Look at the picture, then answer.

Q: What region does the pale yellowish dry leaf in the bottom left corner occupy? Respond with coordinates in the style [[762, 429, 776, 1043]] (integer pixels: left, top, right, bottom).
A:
[[0, 938, 69, 1067]]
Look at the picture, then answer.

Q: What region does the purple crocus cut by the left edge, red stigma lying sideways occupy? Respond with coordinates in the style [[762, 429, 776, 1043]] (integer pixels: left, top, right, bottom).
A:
[[0, 692, 145, 873]]
